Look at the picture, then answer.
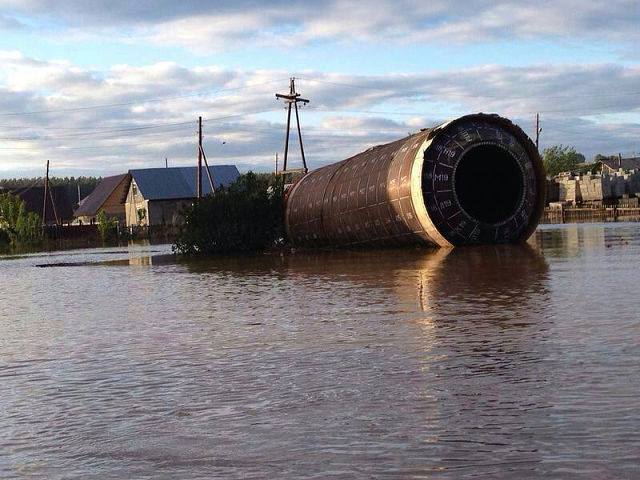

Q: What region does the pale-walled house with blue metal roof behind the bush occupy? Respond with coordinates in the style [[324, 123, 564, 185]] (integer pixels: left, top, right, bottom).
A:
[[125, 165, 240, 226]]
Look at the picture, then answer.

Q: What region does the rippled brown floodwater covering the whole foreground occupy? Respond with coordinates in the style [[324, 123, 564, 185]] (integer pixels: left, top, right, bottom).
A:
[[0, 224, 640, 479]]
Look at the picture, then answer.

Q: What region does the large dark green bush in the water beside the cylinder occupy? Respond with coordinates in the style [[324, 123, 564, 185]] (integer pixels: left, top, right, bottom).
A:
[[174, 172, 284, 255]]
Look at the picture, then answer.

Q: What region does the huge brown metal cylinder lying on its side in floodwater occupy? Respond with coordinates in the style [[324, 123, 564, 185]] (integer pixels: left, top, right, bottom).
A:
[[286, 113, 545, 247]]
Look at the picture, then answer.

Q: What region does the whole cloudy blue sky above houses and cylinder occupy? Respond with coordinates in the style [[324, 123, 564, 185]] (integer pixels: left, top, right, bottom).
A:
[[0, 0, 640, 178]]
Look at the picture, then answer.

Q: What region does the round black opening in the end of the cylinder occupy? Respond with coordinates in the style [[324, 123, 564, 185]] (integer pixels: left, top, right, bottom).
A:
[[455, 145, 524, 224]]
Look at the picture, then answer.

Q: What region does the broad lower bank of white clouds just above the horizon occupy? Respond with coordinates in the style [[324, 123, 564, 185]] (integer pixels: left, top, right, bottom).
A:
[[0, 51, 640, 176]]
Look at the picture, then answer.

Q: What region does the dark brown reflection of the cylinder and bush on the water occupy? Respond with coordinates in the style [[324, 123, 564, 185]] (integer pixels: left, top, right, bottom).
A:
[[176, 244, 549, 321]]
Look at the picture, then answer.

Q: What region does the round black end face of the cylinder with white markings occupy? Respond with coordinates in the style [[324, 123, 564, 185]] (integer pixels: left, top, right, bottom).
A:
[[422, 119, 537, 245]]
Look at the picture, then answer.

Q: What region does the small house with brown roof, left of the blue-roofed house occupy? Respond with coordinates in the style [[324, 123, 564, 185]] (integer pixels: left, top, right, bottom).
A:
[[74, 173, 131, 224]]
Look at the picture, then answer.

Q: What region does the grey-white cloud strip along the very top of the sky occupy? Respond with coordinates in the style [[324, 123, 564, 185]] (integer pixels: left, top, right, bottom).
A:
[[0, 0, 640, 52]]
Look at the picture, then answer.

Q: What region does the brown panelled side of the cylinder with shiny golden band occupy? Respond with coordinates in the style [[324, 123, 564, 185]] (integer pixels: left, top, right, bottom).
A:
[[287, 131, 431, 246]]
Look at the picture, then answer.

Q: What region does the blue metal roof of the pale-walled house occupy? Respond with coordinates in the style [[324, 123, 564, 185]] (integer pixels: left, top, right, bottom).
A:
[[129, 165, 240, 200]]
